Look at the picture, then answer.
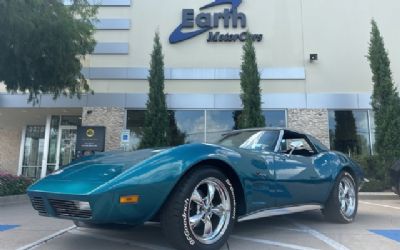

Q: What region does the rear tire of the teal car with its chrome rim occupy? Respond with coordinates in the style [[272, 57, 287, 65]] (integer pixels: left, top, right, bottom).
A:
[[322, 171, 358, 224]]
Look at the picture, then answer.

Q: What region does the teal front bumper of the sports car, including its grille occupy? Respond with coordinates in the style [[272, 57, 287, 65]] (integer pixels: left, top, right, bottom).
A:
[[28, 188, 158, 225]]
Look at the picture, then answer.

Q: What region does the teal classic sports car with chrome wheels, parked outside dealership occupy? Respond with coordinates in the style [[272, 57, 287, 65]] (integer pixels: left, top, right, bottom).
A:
[[28, 129, 364, 249]]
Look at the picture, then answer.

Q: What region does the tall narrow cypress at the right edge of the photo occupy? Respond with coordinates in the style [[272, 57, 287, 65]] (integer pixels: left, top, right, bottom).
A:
[[367, 20, 400, 161]]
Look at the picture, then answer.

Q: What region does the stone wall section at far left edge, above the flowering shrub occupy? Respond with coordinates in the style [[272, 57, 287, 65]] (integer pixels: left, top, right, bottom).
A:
[[0, 128, 22, 175]]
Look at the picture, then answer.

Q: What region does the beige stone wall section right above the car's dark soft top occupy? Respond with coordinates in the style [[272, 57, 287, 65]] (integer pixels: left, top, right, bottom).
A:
[[288, 109, 330, 147]]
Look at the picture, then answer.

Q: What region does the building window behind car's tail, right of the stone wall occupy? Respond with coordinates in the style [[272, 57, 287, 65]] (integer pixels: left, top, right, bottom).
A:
[[329, 110, 373, 155]]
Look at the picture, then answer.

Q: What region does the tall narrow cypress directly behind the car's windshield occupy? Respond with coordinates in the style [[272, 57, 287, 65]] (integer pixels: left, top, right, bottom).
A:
[[238, 33, 265, 129]]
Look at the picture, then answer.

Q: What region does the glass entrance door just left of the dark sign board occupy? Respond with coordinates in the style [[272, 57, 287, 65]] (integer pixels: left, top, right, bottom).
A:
[[57, 126, 77, 168]]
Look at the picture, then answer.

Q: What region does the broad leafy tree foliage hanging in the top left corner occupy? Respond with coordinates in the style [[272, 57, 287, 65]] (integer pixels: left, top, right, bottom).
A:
[[0, 0, 97, 101]]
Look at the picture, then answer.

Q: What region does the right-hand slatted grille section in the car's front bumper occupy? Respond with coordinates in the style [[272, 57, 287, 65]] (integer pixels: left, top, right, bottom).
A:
[[49, 199, 92, 219]]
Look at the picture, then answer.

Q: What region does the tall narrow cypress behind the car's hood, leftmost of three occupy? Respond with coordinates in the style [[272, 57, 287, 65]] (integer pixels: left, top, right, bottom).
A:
[[139, 33, 169, 148]]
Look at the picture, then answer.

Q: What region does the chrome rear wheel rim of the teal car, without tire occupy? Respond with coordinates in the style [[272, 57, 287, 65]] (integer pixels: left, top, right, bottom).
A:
[[339, 177, 356, 218]]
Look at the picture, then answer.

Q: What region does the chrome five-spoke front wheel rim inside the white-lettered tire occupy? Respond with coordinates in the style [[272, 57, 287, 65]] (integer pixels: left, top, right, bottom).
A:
[[188, 177, 231, 245]]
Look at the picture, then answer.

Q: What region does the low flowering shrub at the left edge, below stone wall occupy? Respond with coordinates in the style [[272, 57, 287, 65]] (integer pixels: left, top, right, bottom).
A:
[[0, 172, 33, 196]]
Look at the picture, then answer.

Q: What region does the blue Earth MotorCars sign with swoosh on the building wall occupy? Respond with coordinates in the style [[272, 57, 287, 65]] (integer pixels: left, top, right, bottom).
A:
[[169, 0, 263, 44]]
